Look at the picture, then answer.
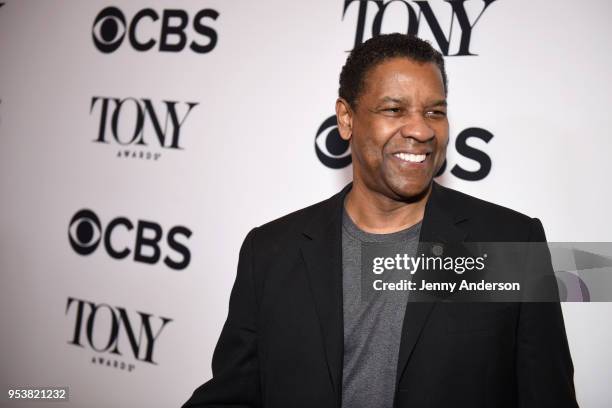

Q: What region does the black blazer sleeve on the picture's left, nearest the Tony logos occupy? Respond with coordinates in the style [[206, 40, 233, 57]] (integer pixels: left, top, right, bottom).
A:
[[183, 228, 261, 408]]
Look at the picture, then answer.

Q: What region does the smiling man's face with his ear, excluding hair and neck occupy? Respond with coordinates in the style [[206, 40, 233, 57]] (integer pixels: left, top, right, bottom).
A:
[[336, 58, 448, 201]]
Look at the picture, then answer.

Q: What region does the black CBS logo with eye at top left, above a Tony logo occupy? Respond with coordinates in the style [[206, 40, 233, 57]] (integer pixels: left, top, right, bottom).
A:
[[92, 7, 219, 54]]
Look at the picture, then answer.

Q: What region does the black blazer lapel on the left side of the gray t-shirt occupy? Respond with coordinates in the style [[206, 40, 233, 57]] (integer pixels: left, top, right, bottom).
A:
[[301, 183, 352, 402]]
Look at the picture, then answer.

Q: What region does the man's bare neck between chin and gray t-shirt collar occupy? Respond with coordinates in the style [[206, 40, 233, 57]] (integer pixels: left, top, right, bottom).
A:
[[345, 181, 431, 234]]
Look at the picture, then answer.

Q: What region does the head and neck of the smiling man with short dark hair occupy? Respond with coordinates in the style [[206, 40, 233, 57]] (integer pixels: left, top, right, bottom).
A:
[[336, 48, 448, 233]]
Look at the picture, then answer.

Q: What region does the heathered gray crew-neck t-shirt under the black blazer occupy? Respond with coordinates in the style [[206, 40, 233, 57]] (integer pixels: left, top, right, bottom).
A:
[[342, 206, 421, 408]]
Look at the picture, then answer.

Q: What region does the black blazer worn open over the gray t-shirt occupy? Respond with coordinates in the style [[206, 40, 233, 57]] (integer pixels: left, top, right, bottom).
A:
[[184, 183, 578, 408]]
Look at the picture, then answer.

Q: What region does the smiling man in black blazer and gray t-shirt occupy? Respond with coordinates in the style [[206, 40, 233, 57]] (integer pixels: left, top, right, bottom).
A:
[[185, 34, 577, 408]]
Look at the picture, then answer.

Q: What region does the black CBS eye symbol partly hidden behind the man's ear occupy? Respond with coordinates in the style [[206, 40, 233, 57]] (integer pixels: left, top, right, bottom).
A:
[[315, 115, 351, 169]]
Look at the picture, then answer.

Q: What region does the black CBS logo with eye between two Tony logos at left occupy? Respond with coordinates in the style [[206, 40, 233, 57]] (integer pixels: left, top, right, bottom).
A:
[[68, 209, 192, 270]]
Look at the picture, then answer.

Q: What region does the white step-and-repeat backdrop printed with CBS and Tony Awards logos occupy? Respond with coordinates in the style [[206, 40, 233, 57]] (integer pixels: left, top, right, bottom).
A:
[[0, 0, 612, 407]]
